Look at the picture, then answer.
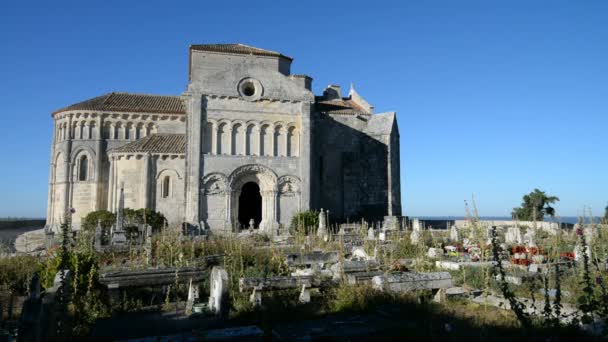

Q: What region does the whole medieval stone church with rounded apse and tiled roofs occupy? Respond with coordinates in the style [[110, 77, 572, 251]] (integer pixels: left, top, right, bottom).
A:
[[47, 44, 401, 233]]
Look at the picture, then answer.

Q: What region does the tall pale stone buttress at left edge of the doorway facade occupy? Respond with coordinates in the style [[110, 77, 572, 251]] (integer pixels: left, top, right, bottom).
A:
[[185, 93, 206, 224]]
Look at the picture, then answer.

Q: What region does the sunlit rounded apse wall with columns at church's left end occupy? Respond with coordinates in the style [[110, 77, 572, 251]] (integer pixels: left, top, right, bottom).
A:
[[47, 111, 185, 229]]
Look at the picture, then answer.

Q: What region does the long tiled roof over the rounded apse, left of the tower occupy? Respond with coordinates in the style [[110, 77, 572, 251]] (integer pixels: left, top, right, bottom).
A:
[[53, 92, 186, 114]]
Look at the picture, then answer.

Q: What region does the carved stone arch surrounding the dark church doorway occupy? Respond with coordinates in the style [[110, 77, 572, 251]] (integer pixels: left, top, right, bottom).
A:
[[228, 164, 278, 234]]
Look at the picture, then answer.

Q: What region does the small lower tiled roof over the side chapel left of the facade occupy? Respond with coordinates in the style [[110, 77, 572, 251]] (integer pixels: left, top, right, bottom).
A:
[[109, 133, 186, 154]]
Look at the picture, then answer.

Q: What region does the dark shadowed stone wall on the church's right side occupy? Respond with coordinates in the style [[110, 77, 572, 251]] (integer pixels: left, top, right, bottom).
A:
[[312, 114, 388, 221]]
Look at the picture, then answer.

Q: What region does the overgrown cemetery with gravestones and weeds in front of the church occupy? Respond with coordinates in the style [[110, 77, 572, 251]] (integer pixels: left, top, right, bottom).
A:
[[0, 198, 608, 340]]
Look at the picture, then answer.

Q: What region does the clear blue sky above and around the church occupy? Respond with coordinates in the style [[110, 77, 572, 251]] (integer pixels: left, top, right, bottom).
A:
[[0, 0, 608, 216]]
